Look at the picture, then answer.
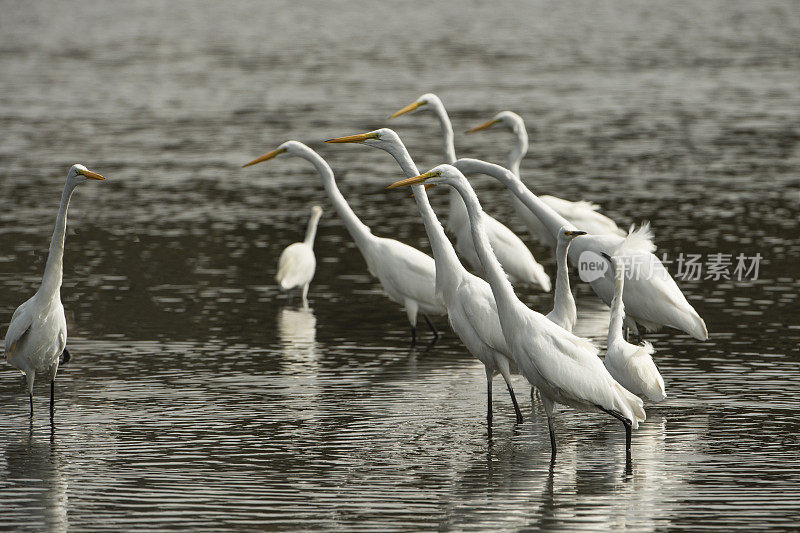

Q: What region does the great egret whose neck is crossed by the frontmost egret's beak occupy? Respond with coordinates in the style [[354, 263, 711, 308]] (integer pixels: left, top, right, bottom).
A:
[[324, 128, 522, 424]]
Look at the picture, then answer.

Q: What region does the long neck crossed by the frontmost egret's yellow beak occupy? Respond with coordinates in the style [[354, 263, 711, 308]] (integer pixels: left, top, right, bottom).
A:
[[387, 142, 465, 287]]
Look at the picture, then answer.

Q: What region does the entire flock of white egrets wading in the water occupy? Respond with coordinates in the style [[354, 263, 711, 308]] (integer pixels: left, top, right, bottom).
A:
[[5, 94, 708, 460]]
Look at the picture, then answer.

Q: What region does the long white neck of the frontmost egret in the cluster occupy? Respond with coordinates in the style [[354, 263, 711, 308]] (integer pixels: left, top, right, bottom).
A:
[[454, 180, 519, 322]]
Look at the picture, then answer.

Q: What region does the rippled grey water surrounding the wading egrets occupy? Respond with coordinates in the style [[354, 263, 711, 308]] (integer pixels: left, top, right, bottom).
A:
[[0, 1, 800, 531]]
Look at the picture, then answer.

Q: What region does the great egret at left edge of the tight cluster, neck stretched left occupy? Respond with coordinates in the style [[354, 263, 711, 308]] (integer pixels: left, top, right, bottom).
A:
[[243, 141, 447, 346]]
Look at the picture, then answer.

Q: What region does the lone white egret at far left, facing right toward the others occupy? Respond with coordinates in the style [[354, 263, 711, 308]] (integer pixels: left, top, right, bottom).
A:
[[5, 165, 105, 418]]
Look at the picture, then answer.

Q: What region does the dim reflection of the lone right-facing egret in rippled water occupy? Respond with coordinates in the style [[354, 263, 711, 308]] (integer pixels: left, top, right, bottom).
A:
[[5, 422, 69, 531]]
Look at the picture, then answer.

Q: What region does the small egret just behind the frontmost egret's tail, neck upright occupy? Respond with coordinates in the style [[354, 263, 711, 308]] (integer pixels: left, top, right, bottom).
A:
[[603, 251, 667, 402]]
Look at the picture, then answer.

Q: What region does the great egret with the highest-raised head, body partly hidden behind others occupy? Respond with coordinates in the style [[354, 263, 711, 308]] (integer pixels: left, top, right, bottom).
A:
[[389, 93, 551, 292]]
